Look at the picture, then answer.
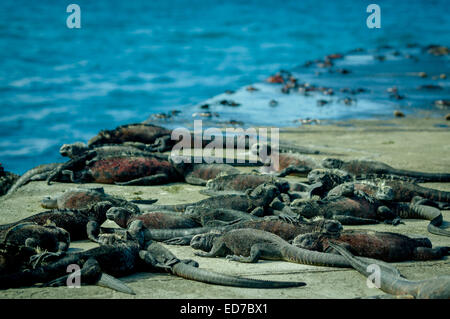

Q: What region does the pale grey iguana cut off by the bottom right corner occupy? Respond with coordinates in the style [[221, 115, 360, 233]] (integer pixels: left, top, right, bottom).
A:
[[330, 243, 450, 299]]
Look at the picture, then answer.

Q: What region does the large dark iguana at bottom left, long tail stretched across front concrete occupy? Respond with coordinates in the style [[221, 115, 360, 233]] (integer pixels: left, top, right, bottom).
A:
[[0, 226, 305, 294]]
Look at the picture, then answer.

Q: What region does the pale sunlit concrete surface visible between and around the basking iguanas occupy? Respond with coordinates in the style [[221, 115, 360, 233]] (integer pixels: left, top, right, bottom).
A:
[[0, 116, 450, 299]]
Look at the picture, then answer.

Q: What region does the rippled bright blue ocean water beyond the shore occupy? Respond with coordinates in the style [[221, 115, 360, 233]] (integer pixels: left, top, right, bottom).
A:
[[0, 0, 450, 173]]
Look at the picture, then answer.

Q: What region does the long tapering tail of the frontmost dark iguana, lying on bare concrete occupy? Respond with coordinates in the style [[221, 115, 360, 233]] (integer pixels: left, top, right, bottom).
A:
[[171, 262, 306, 289]]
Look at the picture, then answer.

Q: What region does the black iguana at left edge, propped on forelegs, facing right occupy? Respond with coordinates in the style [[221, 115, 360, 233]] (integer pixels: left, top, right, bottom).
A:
[[0, 202, 112, 242]]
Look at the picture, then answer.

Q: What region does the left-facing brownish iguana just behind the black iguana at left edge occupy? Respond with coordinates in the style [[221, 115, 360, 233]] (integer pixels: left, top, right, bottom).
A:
[[41, 187, 142, 214]]
